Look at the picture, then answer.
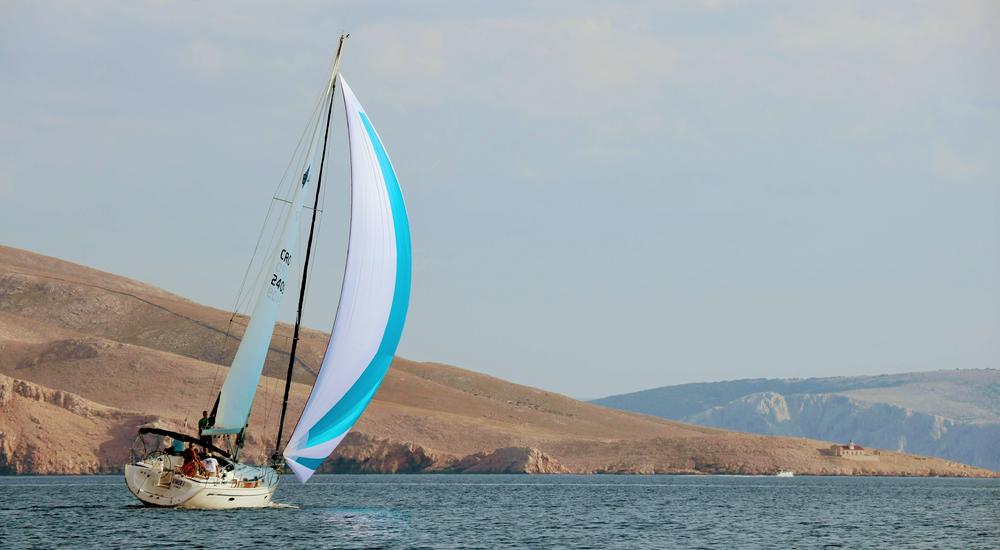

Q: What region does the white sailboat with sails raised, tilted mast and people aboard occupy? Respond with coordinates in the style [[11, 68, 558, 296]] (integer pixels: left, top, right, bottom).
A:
[[124, 35, 411, 509]]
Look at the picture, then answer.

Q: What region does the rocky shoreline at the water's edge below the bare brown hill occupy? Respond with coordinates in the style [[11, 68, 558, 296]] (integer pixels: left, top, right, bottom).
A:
[[0, 375, 1000, 477]]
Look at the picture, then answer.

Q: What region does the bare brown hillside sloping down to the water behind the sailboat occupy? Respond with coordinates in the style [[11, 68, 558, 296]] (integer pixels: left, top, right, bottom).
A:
[[0, 247, 994, 476]]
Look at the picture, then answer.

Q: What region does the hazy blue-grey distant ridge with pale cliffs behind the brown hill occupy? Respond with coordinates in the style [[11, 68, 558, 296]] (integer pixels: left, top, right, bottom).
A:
[[592, 369, 1000, 470]]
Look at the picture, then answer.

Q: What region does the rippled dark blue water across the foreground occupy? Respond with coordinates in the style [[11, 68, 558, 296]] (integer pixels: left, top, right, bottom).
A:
[[0, 475, 1000, 549]]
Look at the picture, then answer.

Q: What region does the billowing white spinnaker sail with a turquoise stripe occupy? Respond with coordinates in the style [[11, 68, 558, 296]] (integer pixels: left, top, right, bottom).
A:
[[284, 77, 411, 482]]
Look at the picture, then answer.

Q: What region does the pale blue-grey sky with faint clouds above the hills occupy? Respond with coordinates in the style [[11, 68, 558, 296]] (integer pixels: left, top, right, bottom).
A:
[[0, 0, 1000, 398]]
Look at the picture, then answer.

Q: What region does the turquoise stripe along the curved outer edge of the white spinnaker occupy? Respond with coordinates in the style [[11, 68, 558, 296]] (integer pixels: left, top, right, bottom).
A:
[[305, 111, 412, 452]]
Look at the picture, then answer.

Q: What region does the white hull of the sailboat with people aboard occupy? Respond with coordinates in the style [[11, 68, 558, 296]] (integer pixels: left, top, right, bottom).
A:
[[125, 457, 278, 510]]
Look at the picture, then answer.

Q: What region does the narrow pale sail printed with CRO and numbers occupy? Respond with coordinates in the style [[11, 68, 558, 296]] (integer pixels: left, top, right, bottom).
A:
[[206, 101, 332, 434]]
